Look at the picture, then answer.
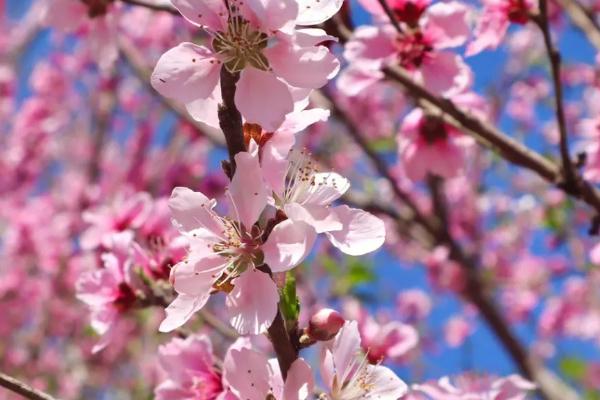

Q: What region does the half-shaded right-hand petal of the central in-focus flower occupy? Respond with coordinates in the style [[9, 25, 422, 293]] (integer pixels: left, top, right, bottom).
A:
[[262, 219, 317, 272]]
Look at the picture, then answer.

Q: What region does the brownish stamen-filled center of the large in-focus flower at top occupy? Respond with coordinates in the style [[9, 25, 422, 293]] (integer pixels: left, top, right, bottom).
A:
[[212, 15, 270, 73]]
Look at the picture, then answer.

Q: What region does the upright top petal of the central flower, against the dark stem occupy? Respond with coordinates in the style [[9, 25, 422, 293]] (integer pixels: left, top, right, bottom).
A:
[[229, 152, 267, 230]]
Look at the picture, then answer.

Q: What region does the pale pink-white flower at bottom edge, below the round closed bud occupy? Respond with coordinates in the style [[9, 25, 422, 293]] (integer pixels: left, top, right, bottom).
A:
[[321, 321, 407, 400]]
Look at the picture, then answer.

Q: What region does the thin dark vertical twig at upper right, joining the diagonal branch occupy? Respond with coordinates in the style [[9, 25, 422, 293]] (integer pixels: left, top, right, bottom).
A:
[[533, 0, 578, 191]]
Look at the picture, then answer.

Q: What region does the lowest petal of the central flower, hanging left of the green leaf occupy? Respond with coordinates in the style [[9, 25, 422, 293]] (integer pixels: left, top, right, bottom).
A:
[[225, 269, 279, 335]]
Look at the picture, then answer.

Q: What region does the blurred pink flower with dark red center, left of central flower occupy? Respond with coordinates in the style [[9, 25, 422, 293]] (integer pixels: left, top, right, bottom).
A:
[[76, 232, 137, 352]]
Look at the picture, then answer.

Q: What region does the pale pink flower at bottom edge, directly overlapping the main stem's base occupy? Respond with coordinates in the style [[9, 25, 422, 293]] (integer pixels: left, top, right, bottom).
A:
[[223, 338, 314, 400]]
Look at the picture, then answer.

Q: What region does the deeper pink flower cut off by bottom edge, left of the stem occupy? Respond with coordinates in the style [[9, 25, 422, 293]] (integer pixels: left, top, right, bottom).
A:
[[154, 335, 233, 400]]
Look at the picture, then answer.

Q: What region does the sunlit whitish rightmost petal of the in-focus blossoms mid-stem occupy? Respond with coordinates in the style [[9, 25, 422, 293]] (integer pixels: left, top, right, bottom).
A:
[[326, 205, 385, 256]]
